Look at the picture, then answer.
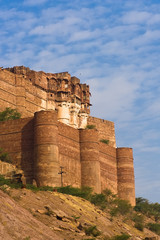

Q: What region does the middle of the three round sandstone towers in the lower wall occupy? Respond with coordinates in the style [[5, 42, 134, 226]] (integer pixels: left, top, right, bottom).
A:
[[79, 129, 101, 193]]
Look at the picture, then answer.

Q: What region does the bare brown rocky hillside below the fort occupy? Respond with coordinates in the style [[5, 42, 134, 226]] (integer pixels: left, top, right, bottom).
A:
[[0, 186, 160, 240]]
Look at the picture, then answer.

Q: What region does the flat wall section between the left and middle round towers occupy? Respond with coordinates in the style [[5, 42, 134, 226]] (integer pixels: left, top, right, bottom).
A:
[[58, 123, 81, 187]]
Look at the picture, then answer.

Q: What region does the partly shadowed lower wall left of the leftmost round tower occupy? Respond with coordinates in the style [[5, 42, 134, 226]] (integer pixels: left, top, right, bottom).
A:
[[0, 118, 33, 183]]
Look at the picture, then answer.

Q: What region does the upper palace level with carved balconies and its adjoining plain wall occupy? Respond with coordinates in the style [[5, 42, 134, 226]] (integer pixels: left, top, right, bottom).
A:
[[0, 66, 91, 128]]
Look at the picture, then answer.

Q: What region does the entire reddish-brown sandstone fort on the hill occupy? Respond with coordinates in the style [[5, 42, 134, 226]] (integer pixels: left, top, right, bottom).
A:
[[0, 66, 135, 206]]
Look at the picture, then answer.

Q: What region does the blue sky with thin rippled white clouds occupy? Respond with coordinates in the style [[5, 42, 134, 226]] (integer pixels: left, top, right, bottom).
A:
[[0, 0, 160, 202]]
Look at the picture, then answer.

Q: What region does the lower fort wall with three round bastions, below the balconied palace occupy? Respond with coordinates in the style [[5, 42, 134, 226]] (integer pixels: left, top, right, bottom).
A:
[[0, 110, 135, 205]]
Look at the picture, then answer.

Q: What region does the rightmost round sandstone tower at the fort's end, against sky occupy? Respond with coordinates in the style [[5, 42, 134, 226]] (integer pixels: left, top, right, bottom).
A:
[[116, 148, 135, 206]]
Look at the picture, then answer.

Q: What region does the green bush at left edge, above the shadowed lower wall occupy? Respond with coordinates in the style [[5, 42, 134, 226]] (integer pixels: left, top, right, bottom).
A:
[[0, 107, 21, 121]]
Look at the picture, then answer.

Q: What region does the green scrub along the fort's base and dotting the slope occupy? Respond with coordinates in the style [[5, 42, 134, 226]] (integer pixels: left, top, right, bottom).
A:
[[0, 173, 160, 240]]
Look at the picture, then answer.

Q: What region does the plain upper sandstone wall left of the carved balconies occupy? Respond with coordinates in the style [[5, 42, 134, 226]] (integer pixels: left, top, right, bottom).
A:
[[0, 69, 54, 117]]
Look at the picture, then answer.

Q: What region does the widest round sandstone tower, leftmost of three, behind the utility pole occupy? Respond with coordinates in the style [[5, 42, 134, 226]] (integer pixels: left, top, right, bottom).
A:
[[34, 110, 60, 187]]
